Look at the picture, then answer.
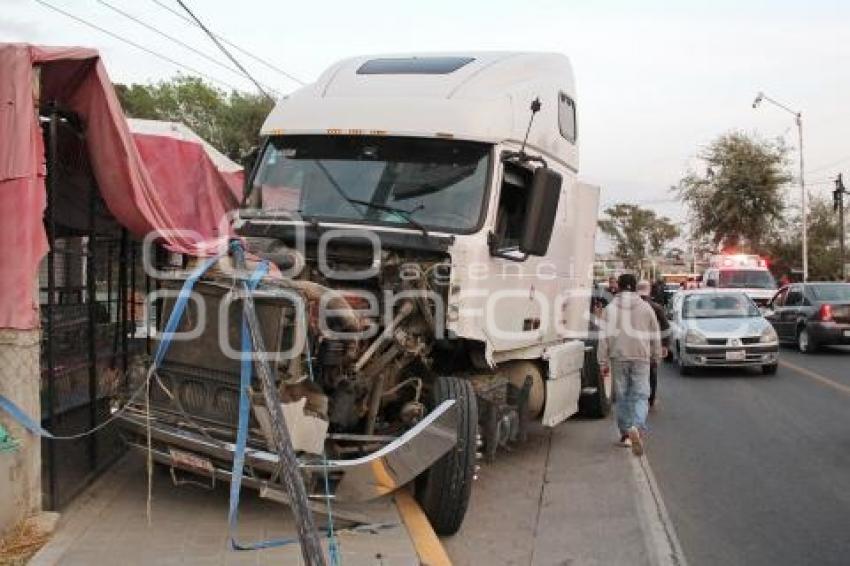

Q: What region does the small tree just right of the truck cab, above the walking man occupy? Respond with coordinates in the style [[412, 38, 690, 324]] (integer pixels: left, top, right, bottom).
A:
[[599, 203, 679, 270]]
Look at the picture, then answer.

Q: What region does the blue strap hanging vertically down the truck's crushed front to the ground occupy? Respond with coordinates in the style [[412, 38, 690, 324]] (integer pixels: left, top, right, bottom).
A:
[[227, 261, 298, 550]]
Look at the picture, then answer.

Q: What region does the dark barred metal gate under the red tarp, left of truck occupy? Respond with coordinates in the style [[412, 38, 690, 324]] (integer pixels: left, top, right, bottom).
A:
[[39, 108, 147, 509]]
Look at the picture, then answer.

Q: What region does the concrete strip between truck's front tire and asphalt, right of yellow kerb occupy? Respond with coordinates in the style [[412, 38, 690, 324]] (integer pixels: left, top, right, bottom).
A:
[[443, 419, 685, 566]]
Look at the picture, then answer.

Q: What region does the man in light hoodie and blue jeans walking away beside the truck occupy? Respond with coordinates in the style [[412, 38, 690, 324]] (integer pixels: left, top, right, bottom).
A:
[[598, 273, 661, 456]]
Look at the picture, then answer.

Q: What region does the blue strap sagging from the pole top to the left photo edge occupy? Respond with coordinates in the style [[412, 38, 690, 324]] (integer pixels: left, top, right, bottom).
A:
[[0, 255, 222, 440]]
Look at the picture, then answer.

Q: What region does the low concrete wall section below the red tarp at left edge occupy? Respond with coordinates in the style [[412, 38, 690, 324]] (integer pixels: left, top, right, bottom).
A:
[[0, 329, 41, 534]]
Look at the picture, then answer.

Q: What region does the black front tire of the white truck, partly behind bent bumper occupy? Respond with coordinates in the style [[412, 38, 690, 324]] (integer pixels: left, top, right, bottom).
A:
[[416, 377, 478, 535]]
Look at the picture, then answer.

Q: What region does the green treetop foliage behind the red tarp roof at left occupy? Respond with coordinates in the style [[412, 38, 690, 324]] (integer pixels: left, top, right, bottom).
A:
[[115, 75, 273, 167]]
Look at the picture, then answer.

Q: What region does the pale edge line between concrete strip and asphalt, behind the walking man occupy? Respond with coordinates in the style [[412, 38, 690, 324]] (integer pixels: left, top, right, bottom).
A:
[[627, 454, 688, 566]]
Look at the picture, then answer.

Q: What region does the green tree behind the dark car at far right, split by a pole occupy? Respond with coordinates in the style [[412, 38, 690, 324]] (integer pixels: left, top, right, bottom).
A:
[[765, 197, 841, 281]]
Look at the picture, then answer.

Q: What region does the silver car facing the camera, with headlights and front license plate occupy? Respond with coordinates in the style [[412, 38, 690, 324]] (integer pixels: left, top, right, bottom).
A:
[[669, 288, 779, 375]]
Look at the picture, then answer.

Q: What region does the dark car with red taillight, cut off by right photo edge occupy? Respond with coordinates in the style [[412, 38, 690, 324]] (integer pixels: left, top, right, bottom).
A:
[[765, 282, 850, 353]]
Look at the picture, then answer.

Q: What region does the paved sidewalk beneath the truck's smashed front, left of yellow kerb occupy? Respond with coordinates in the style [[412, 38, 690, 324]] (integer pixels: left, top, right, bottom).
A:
[[29, 454, 419, 566]]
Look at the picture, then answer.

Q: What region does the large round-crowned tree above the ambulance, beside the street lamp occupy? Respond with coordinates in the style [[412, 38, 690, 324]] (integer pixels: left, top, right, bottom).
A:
[[673, 132, 791, 252]]
